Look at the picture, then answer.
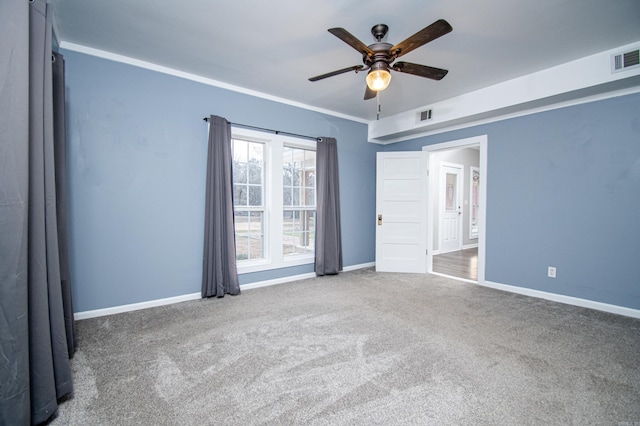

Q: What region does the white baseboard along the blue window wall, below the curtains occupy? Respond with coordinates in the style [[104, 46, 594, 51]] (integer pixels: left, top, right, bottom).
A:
[[73, 262, 375, 321]]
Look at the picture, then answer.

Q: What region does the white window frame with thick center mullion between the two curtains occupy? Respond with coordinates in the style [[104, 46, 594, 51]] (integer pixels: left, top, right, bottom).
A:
[[231, 127, 317, 274]]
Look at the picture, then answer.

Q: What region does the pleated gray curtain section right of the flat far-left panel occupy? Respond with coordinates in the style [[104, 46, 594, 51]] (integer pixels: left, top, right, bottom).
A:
[[28, 0, 73, 424]]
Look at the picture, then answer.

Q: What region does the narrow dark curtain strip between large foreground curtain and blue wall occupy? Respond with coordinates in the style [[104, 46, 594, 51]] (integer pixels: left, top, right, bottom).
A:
[[53, 53, 76, 357]]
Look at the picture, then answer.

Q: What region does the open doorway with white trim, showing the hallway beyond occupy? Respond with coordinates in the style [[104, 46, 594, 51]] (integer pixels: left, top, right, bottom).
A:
[[423, 135, 487, 282]]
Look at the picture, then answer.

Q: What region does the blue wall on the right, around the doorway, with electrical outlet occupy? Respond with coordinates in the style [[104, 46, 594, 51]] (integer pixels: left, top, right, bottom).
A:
[[385, 94, 640, 309]]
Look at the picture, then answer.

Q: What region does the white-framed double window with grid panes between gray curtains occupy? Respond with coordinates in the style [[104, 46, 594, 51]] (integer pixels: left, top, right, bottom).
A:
[[232, 128, 316, 273]]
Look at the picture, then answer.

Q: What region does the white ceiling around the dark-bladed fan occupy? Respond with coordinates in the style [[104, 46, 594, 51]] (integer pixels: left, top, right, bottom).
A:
[[50, 0, 640, 120]]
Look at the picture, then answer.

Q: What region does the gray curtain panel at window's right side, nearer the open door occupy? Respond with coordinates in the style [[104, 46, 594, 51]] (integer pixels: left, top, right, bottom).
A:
[[315, 138, 342, 276]]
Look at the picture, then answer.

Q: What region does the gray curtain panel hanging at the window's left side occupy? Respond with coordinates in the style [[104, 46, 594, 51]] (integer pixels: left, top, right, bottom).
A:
[[202, 115, 240, 297]]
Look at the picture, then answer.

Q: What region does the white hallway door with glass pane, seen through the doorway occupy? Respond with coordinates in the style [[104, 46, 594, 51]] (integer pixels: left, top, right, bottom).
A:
[[440, 163, 463, 253]]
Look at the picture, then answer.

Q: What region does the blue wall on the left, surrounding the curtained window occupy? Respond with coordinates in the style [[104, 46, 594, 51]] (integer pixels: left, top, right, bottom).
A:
[[61, 50, 378, 312]]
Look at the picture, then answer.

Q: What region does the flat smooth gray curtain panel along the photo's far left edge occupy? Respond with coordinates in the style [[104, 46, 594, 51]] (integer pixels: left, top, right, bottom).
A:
[[0, 0, 30, 425]]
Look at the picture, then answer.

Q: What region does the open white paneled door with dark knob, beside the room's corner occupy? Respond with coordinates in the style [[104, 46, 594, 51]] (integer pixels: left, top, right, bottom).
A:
[[375, 151, 427, 273]]
